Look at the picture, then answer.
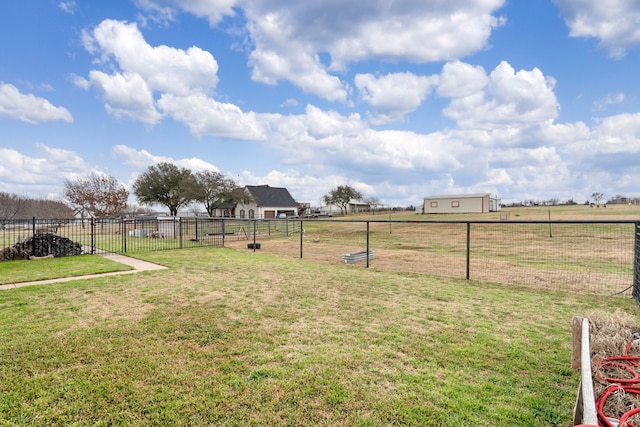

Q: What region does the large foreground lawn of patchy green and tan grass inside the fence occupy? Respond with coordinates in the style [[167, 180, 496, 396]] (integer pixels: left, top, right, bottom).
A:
[[0, 248, 638, 426]]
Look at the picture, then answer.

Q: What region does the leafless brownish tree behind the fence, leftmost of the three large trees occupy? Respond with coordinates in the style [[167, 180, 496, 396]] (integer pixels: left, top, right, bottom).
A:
[[64, 172, 129, 218]]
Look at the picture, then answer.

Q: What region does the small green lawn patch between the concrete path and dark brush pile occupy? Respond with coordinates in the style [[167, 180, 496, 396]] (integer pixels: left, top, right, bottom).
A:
[[0, 255, 131, 285]]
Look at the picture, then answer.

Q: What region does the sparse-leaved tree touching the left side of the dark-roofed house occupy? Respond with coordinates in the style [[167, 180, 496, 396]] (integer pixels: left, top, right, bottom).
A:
[[195, 171, 248, 216]]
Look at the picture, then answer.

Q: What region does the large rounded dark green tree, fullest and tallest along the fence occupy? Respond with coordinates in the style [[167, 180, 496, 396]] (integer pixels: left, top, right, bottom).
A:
[[133, 162, 198, 216]]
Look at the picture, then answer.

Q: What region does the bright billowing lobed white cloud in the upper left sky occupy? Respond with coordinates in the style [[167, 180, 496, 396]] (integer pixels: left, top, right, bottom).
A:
[[81, 19, 218, 124]]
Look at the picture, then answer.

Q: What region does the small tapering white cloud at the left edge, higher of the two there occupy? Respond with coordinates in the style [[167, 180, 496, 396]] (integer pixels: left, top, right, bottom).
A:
[[0, 82, 73, 124]]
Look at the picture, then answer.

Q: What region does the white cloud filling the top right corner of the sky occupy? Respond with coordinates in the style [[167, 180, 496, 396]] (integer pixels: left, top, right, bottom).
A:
[[554, 0, 640, 58]]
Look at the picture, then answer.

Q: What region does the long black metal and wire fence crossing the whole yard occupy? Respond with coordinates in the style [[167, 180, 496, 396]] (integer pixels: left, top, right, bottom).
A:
[[0, 217, 640, 303]]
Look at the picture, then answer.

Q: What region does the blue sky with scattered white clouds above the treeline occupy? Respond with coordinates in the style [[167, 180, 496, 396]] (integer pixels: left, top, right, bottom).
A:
[[0, 0, 640, 206]]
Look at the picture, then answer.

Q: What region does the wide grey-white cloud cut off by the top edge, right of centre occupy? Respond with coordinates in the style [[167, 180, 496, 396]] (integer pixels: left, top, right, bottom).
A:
[[324, 0, 504, 68]]
